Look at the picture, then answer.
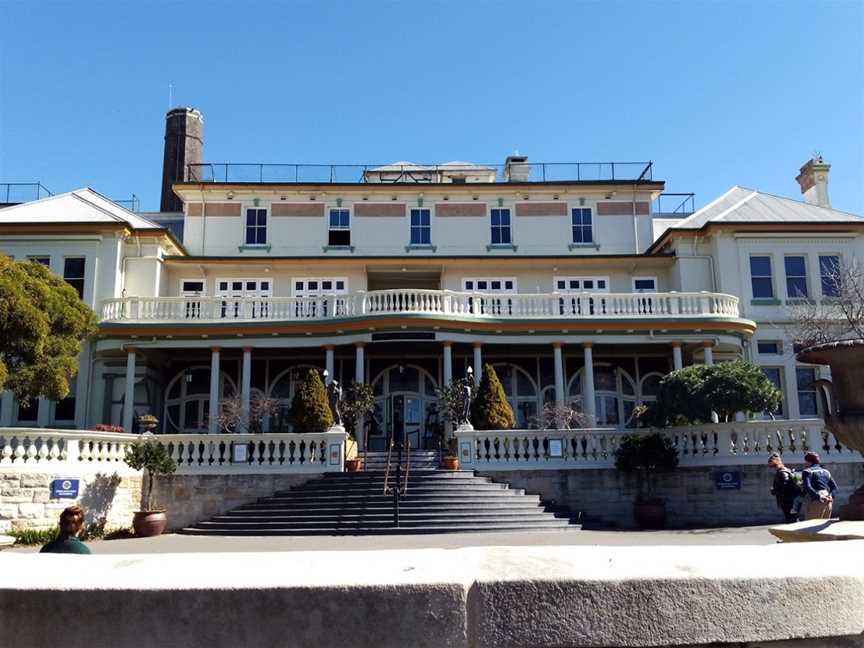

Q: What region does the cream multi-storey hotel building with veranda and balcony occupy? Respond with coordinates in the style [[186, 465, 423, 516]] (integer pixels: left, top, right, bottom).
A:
[[0, 157, 864, 449]]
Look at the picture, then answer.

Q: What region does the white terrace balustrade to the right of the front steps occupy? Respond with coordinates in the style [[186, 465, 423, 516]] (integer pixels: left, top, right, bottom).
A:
[[456, 419, 864, 470]]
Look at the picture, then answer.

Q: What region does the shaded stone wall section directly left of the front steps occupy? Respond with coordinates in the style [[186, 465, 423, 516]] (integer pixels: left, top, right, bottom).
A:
[[154, 473, 321, 529]]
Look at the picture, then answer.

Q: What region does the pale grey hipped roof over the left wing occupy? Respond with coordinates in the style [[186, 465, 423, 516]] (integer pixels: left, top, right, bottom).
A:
[[0, 187, 164, 230]]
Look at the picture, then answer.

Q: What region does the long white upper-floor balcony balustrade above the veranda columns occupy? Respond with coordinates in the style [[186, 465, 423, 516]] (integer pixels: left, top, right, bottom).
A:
[[101, 289, 738, 323]]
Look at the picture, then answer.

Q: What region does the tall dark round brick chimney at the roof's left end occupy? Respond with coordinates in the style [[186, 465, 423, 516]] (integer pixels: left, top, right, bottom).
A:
[[159, 108, 204, 212]]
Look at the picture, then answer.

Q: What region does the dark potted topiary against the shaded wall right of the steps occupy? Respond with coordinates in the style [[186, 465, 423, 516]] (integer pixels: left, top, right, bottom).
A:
[[615, 432, 678, 529]]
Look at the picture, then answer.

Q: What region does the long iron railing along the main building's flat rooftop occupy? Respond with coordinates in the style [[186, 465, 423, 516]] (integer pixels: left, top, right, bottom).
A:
[[185, 161, 653, 184]]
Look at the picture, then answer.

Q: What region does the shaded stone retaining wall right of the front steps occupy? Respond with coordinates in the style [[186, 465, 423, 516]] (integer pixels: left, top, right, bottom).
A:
[[478, 463, 864, 528]]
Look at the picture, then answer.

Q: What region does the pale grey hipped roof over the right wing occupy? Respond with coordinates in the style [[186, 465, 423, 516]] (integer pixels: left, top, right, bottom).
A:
[[648, 185, 864, 254]]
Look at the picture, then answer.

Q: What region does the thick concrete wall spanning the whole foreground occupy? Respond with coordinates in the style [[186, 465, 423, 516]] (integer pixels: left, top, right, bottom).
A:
[[0, 541, 864, 648]]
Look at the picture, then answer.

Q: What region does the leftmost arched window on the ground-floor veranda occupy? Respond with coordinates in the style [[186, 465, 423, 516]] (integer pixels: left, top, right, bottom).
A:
[[163, 366, 237, 434]]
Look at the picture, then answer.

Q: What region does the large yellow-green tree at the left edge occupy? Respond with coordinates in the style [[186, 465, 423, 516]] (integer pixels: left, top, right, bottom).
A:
[[0, 257, 96, 403]]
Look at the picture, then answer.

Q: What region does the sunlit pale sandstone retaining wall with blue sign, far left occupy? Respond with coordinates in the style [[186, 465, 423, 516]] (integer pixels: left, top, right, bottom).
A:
[[0, 467, 142, 532]]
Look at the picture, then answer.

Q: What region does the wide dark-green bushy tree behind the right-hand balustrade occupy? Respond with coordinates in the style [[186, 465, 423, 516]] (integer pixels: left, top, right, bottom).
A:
[[653, 361, 781, 425]]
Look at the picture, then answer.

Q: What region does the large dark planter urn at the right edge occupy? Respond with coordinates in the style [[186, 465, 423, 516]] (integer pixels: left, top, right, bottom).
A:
[[797, 340, 864, 520]]
